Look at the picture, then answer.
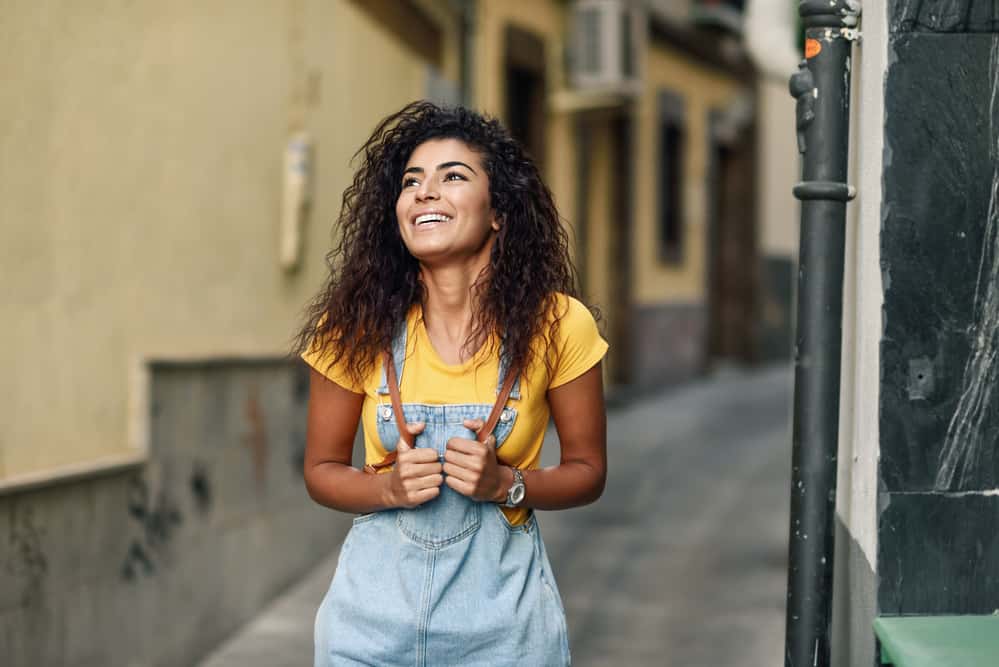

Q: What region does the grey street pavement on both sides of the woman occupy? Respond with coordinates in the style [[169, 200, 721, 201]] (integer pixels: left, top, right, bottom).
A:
[[200, 365, 792, 667]]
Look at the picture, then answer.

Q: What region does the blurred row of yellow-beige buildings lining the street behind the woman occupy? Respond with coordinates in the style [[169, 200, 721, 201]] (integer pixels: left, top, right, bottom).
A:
[[0, 0, 798, 665]]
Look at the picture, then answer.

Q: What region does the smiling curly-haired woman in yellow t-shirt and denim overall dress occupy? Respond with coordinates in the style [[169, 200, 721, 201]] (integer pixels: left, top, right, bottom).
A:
[[299, 102, 607, 666]]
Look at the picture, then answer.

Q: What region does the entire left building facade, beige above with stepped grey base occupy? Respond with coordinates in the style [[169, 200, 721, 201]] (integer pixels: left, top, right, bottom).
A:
[[0, 0, 460, 667]]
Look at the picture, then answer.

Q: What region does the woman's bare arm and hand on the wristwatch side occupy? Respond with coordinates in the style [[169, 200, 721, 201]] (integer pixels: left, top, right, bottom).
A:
[[444, 363, 607, 510]]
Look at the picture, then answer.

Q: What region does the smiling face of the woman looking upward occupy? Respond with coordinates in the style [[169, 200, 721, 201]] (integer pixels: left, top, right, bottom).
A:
[[395, 139, 499, 263]]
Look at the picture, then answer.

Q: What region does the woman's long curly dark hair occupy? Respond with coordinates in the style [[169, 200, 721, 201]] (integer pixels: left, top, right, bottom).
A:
[[295, 101, 578, 385]]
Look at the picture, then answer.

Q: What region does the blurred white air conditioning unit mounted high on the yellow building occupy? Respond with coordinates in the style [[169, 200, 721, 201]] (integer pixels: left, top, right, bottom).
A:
[[569, 0, 646, 95]]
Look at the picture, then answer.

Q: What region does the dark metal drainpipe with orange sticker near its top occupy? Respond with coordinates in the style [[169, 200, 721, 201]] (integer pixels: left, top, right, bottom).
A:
[[784, 0, 860, 667]]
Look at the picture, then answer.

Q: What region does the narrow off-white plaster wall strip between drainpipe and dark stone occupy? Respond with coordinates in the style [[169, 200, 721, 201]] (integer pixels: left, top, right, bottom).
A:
[[832, 2, 888, 667]]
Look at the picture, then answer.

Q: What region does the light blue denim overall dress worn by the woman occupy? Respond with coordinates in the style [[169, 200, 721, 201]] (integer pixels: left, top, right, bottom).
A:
[[315, 327, 569, 667]]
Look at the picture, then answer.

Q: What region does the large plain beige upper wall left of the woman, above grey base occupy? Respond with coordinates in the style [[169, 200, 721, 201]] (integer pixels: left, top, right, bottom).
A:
[[0, 0, 454, 480]]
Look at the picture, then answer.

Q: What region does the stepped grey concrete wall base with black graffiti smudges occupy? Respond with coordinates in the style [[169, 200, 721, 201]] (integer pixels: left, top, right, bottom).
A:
[[0, 361, 350, 667]]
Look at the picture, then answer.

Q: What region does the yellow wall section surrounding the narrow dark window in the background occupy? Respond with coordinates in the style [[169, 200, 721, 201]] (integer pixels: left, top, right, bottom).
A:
[[633, 44, 740, 305]]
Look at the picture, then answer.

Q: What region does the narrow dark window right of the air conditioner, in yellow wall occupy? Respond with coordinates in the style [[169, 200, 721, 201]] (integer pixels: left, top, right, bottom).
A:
[[658, 91, 686, 264]]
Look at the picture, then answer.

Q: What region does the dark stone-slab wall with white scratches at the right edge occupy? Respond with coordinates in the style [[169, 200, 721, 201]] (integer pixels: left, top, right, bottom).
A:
[[877, 0, 999, 614]]
